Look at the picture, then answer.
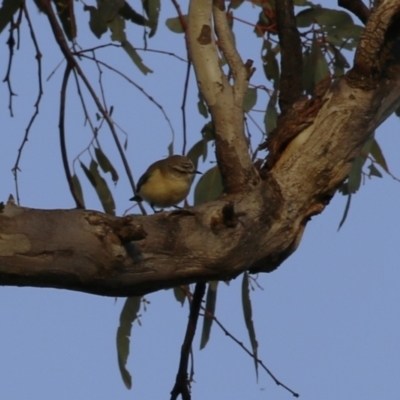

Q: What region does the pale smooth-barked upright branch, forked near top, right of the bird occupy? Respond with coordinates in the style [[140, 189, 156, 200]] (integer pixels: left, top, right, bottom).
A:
[[188, 0, 259, 193]]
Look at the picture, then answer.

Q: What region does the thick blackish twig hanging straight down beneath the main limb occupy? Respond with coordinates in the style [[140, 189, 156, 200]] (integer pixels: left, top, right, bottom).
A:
[[171, 283, 206, 400]]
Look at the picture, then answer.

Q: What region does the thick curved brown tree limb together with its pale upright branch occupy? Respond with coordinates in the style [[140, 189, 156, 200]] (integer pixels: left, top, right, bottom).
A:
[[0, 0, 400, 296]]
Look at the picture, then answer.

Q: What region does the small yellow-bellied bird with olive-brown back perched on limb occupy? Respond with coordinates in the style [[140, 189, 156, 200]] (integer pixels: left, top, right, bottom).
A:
[[130, 155, 201, 212]]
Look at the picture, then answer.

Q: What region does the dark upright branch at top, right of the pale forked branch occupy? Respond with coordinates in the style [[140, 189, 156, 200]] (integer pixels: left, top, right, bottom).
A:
[[275, 0, 303, 113]]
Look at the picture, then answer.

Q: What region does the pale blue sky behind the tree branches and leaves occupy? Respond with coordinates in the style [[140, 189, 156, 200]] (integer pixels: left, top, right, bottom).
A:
[[0, 2, 400, 400]]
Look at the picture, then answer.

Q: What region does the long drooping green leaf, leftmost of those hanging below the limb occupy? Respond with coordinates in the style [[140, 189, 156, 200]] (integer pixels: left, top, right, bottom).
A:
[[117, 297, 141, 389]]
